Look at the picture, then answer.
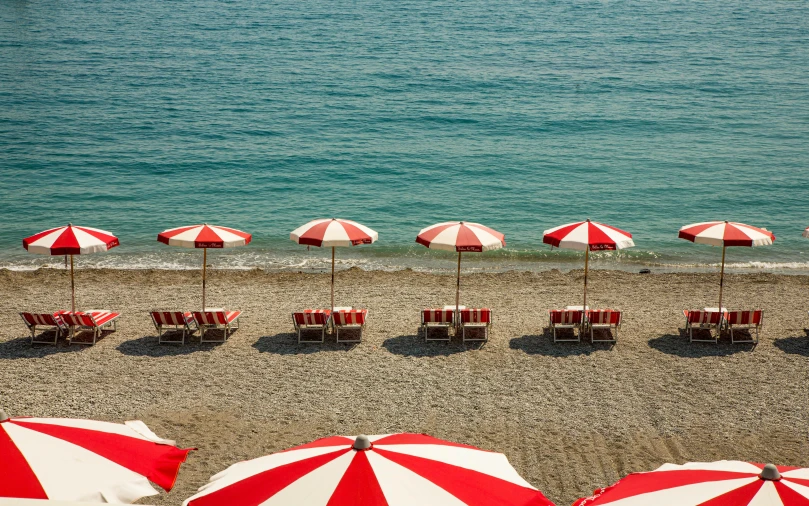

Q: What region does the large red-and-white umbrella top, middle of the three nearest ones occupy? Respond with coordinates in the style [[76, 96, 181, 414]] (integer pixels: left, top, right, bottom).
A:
[[183, 434, 553, 506]]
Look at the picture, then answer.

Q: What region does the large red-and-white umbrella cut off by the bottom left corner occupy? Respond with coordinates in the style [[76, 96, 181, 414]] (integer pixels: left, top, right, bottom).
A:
[[0, 410, 191, 503]]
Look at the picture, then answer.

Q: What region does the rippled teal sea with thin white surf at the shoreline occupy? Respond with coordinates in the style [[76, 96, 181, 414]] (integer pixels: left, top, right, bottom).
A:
[[0, 0, 809, 273]]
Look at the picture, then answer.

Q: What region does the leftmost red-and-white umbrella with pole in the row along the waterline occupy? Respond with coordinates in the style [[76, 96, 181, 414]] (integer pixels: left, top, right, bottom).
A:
[[22, 223, 119, 312]]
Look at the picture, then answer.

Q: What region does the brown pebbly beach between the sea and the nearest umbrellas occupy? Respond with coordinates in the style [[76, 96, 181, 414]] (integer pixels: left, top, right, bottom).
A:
[[0, 269, 809, 505]]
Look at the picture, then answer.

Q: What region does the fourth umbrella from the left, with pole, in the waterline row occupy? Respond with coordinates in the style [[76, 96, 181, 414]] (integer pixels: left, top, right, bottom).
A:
[[416, 221, 506, 322]]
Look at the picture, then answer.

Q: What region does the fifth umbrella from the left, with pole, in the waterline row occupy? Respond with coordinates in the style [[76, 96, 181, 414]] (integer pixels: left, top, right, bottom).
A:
[[542, 220, 635, 310]]
